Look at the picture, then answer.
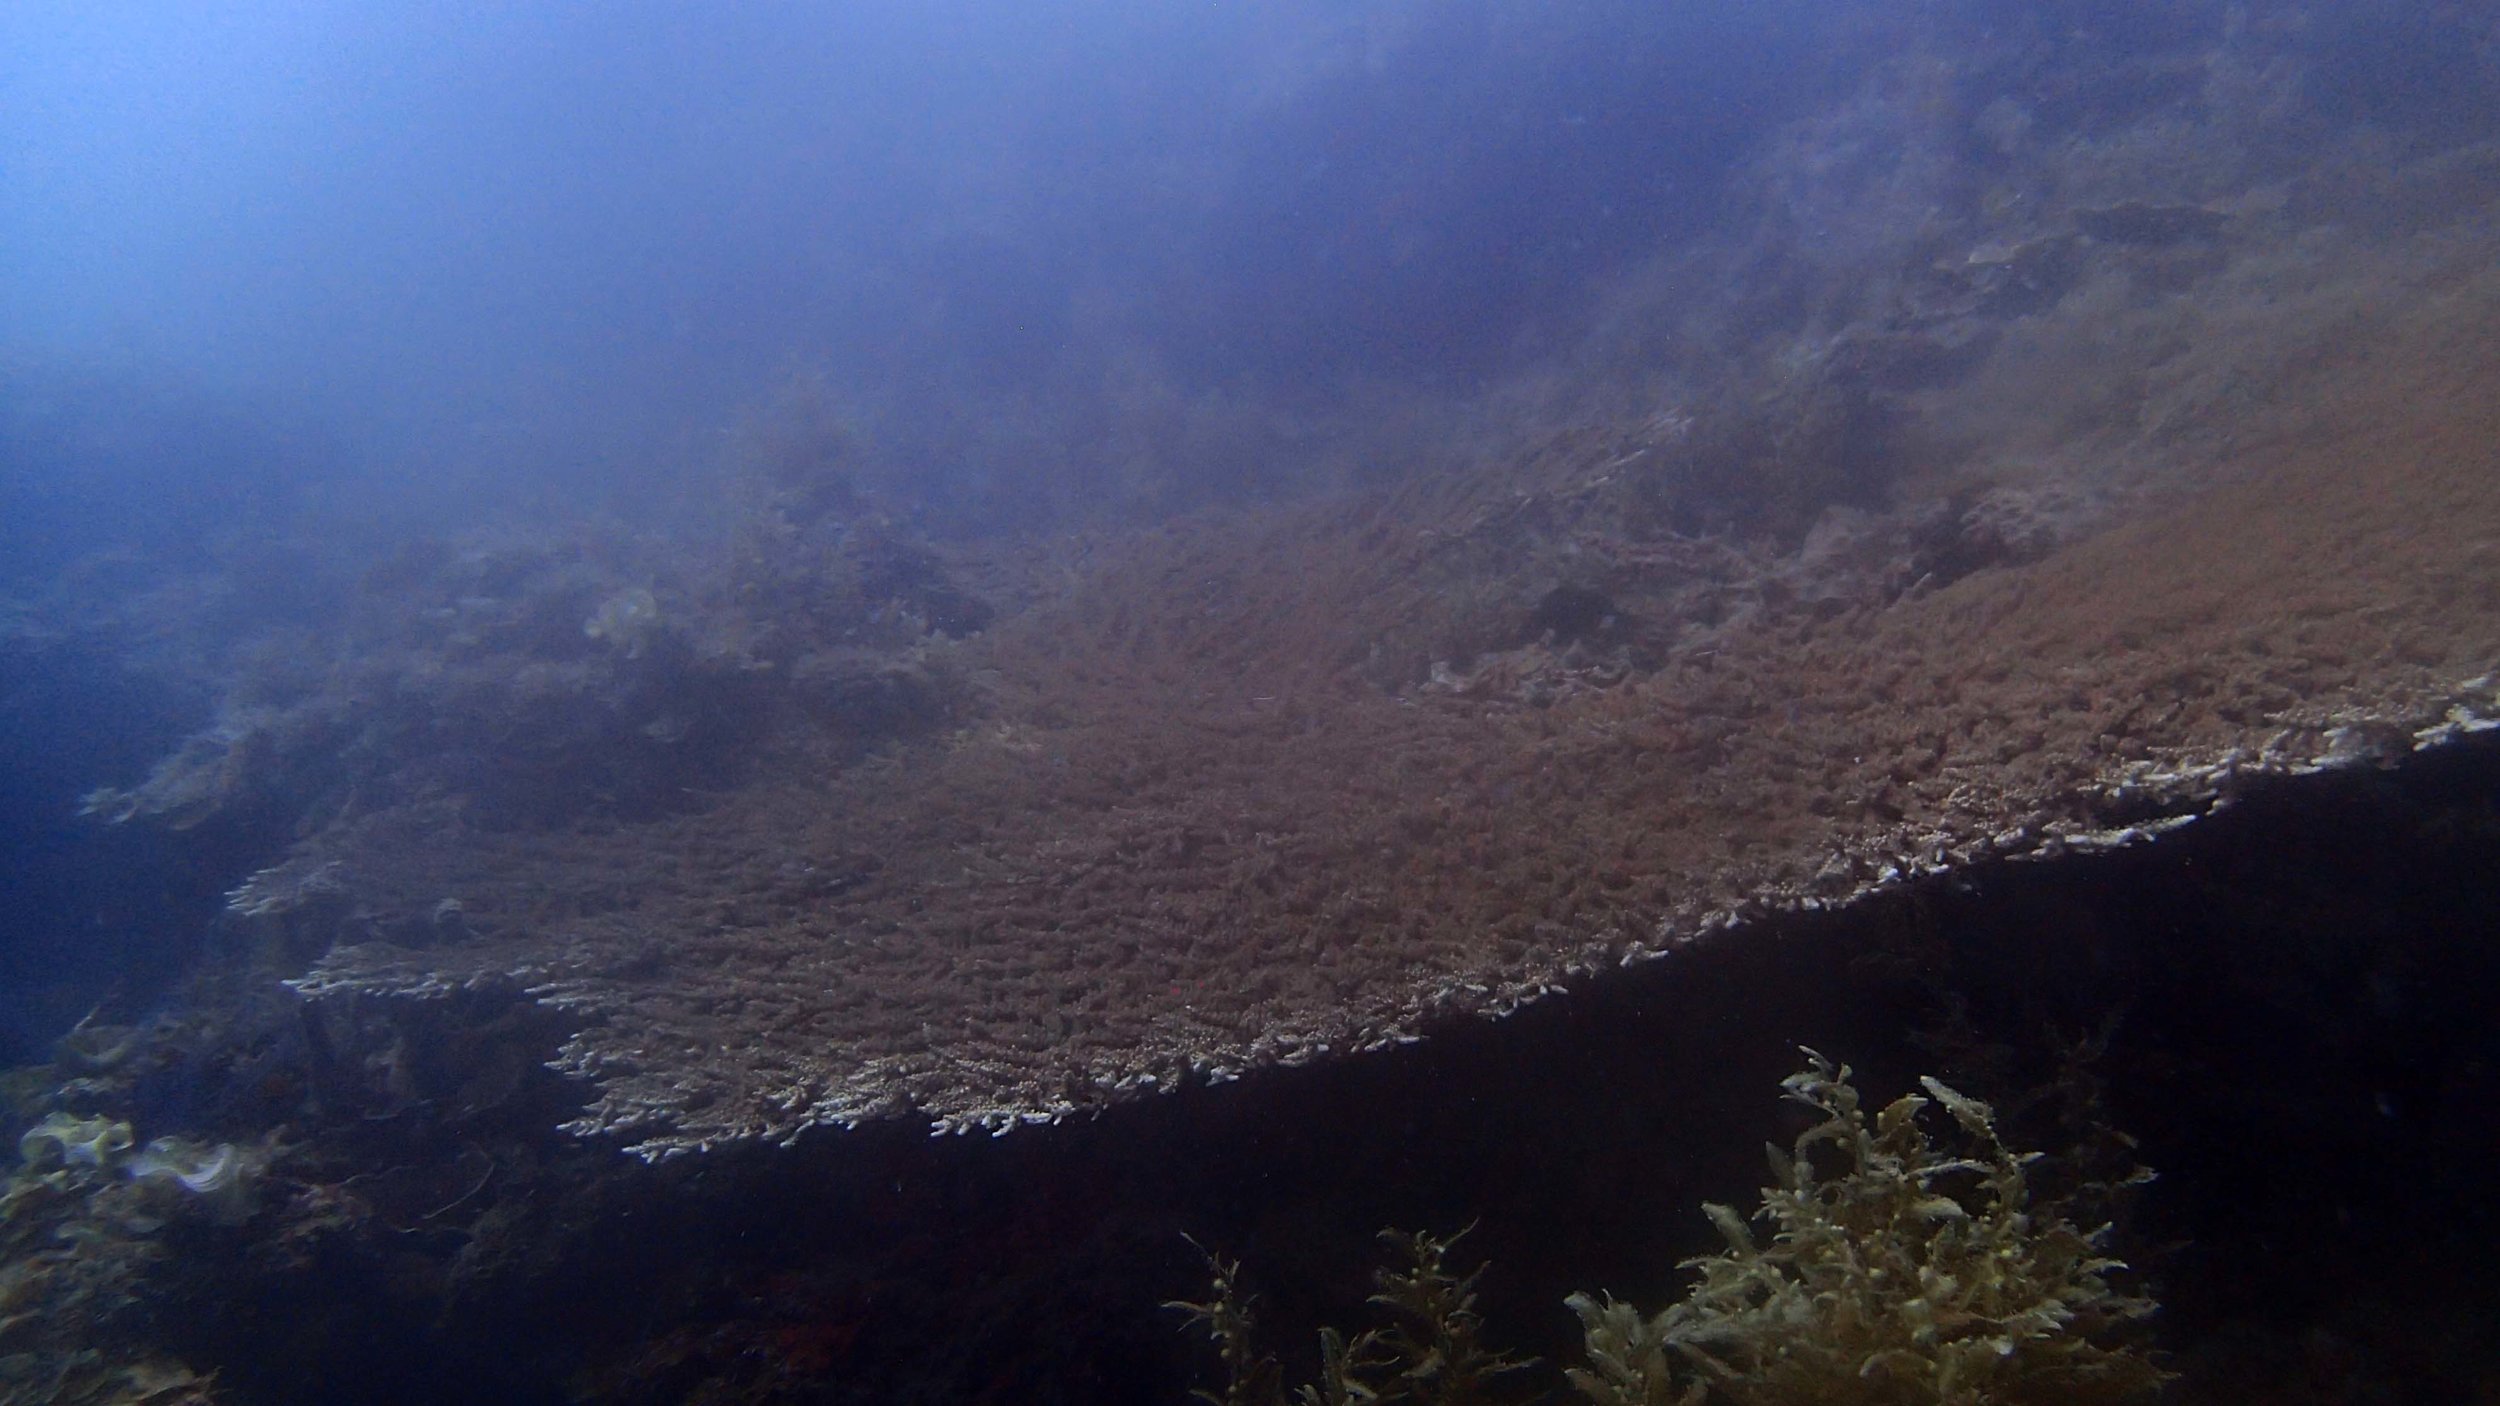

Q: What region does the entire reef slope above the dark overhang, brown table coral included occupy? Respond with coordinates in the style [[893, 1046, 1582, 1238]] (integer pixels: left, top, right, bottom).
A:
[[68, 5, 2500, 1158]]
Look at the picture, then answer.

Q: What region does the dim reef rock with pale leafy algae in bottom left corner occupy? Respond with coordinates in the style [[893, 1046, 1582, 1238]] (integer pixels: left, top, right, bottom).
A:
[[0, 973, 580, 1406]]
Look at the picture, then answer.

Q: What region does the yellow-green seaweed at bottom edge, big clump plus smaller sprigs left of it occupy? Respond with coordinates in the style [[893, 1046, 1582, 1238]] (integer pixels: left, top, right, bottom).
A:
[[1175, 1051, 2168, 1406]]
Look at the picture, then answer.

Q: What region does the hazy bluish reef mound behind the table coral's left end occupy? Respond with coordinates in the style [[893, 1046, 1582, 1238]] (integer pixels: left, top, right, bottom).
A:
[[65, 467, 990, 831]]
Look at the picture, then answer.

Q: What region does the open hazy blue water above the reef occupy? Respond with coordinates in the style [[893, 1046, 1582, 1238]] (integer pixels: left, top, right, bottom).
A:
[[0, 0, 1843, 518]]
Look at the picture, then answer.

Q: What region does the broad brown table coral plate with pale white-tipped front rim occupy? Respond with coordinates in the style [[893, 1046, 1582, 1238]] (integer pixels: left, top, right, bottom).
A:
[[290, 280, 2500, 1156]]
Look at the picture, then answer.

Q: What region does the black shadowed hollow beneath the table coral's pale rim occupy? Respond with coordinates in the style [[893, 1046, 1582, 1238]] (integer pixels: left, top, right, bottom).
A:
[[14, 738, 2500, 1406]]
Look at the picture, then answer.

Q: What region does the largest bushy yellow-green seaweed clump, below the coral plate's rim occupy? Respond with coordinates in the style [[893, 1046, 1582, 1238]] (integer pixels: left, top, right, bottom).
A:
[[1568, 1051, 2168, 1406]]
